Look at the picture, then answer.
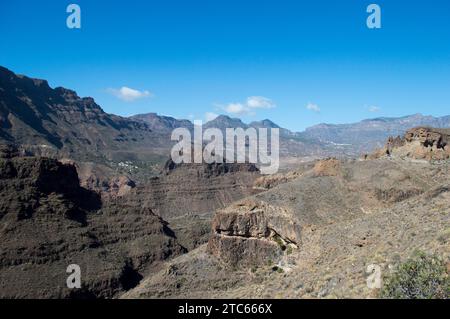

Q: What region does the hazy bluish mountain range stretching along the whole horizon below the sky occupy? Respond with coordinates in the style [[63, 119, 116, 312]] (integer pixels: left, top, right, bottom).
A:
[[0, 67, 450, 167]]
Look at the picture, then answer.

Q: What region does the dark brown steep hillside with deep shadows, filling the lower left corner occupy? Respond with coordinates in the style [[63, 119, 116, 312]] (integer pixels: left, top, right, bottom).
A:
[[0, 147, 185, 298]]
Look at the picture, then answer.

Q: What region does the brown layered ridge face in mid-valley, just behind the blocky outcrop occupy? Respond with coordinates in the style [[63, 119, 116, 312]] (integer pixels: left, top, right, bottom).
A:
[[124, 160, 260, 222]]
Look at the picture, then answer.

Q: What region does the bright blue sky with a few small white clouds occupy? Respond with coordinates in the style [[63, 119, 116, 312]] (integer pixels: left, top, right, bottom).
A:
[[0, 0, 450, 131]]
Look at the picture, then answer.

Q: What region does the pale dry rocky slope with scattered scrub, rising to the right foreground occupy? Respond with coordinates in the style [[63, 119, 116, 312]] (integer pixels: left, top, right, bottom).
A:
[[122, 128, 450, 298]]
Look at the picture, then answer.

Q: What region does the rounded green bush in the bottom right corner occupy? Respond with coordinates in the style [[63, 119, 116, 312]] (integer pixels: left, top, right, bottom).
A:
[[381, 253, 450, 299]]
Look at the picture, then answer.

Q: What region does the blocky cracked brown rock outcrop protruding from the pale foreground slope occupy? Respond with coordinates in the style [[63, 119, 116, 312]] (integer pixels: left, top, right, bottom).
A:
[[208, 200, 301, 266]]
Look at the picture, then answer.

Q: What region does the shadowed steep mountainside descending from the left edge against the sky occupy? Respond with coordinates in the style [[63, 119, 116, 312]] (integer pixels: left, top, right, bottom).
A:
[[0, 67, 172, 163]]
